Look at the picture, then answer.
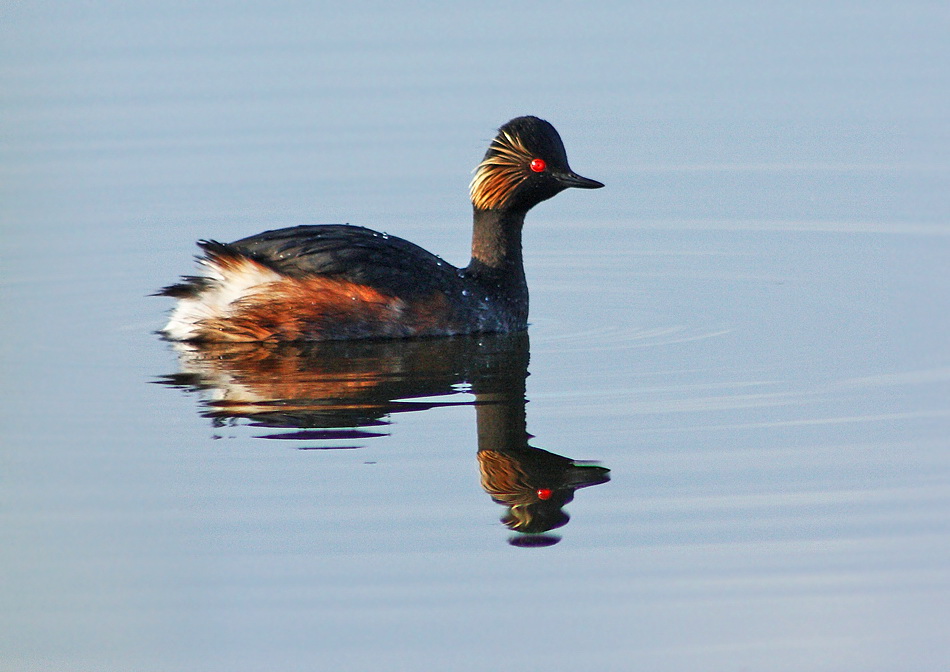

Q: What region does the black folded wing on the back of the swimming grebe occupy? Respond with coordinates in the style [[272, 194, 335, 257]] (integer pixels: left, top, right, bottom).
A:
[[225, 224, 459, 296]]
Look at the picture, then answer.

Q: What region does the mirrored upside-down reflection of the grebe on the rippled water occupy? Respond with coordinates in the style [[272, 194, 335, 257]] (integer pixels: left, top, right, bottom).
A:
[[159, 333, 609, 546]]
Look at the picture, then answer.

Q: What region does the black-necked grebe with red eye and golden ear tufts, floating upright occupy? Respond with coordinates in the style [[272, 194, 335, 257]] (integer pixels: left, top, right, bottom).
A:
[[158, 117, 604, 342]]
